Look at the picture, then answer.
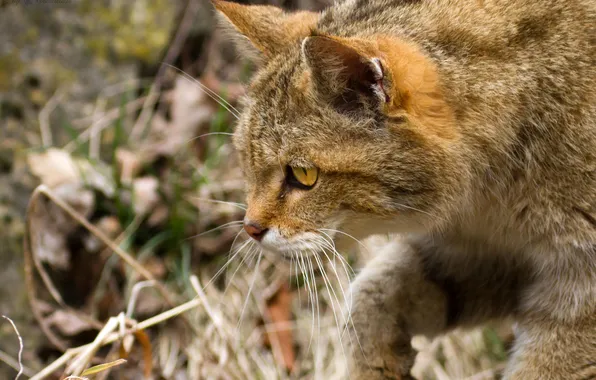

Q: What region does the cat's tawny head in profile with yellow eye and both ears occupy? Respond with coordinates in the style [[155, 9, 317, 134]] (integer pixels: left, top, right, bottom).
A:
[[215, 1, 466, 255]]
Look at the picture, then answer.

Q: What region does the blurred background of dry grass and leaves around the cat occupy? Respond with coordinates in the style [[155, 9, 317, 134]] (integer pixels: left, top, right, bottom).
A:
[[0, 0, 510, 380]]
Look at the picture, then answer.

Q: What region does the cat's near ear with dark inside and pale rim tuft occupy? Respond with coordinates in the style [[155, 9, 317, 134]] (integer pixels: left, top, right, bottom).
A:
[[302, 36, 389, 110]]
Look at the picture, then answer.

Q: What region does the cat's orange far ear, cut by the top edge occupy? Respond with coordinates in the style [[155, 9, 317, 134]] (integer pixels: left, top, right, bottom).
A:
[[212, 0, 319, 59]]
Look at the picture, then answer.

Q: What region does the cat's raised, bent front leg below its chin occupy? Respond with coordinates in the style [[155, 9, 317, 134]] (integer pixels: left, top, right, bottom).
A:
[[348, 242, 447, 380]]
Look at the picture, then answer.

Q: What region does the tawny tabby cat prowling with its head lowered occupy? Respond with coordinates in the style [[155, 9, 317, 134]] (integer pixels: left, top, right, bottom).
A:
[[213, 0, 596, 380]]
